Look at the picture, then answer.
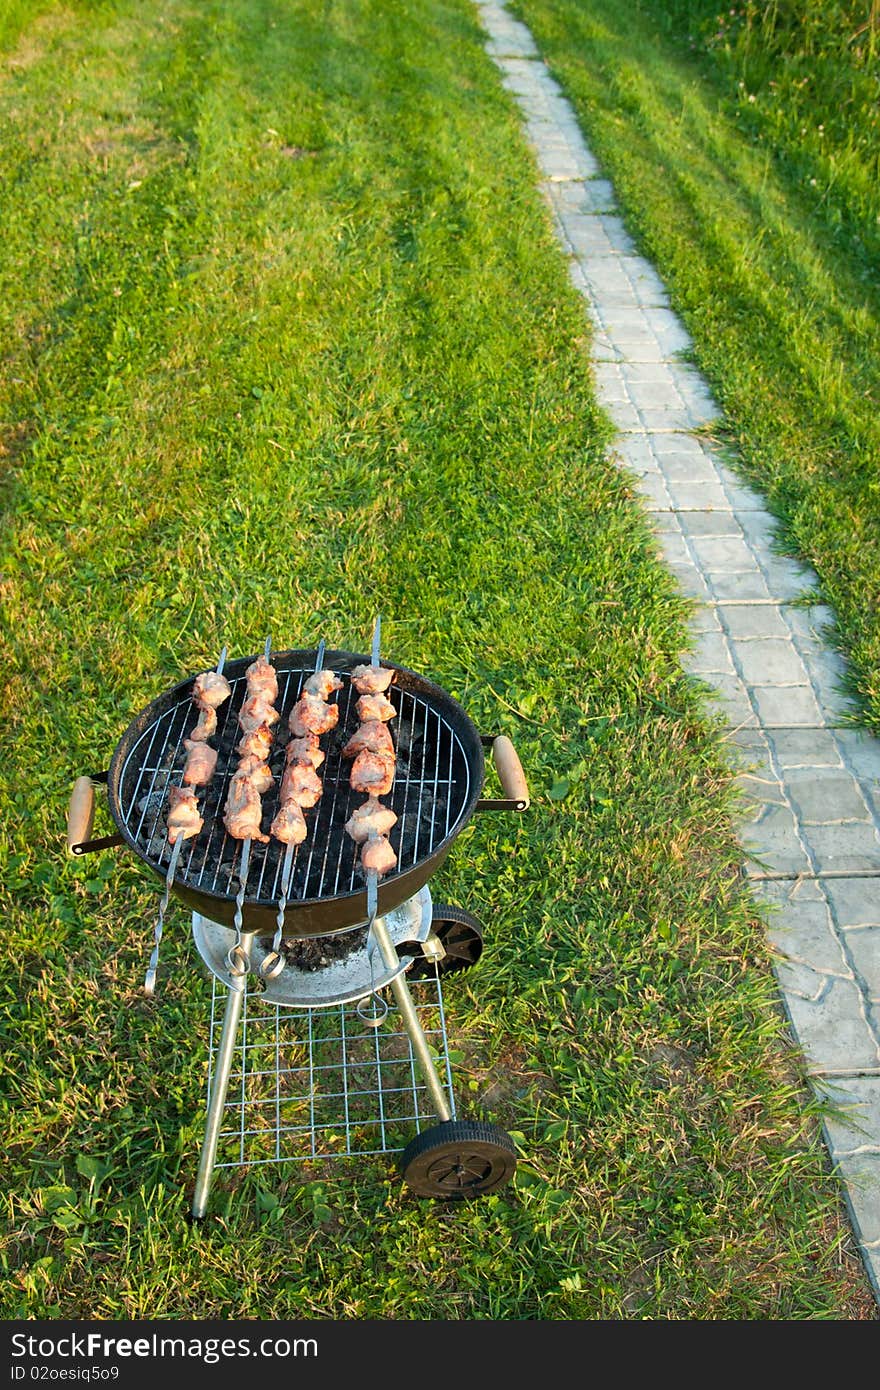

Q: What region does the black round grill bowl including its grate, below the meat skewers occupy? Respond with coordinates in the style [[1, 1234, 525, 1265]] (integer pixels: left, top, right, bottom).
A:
[[107, 649, 485, 937]]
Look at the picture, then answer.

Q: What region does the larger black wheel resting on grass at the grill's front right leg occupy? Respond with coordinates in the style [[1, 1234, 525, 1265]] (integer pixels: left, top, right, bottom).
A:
[[400, 1120, 516, 1201]]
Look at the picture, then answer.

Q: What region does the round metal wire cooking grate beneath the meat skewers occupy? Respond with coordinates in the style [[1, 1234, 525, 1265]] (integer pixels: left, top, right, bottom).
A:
[[120, 663, 470, 905]]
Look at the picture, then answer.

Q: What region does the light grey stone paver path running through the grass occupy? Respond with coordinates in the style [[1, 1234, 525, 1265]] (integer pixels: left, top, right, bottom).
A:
[[475, 0, 880, 1302]]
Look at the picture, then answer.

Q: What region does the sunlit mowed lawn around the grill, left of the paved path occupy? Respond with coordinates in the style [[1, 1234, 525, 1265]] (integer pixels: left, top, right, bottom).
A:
[[0, 0, 874, 1321]]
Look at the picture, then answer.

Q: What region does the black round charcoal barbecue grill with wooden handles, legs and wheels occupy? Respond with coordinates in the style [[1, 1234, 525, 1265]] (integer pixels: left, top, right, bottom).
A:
[[68, 636, 528, 1218]]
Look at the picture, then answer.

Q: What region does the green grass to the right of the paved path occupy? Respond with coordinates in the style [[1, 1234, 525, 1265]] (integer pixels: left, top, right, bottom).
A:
[[517, 0, 880, 733]]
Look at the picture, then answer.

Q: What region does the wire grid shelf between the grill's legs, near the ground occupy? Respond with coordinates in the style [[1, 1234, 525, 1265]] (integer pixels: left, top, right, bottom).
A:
[[209, 972, 455, 1168]]
